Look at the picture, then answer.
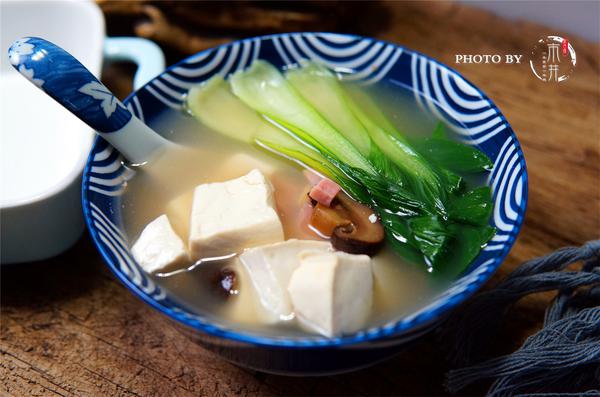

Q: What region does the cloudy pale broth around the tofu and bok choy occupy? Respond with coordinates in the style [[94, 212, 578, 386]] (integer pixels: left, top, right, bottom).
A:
[[122, 59, 489, 336]]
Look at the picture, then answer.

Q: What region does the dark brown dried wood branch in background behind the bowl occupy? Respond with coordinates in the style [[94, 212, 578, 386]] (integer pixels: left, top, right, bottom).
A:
[[97, 0, 371, 54]]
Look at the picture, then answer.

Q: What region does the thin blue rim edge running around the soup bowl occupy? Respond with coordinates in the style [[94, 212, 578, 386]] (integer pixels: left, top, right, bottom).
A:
[[82, 32, 529, 349]]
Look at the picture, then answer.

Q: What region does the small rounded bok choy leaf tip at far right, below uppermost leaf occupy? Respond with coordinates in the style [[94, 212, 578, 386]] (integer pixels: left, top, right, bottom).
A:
[[447, 186, 493, 226]]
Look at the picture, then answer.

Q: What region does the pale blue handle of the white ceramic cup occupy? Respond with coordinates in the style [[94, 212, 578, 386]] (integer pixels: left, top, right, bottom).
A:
[[104, 37, 165, 91]]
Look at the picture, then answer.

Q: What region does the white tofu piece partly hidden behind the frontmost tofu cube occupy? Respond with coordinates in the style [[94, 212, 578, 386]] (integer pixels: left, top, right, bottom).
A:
[[240, 239, 333, 322]]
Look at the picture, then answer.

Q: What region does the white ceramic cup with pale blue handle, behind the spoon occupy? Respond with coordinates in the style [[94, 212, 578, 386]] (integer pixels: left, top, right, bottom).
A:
[[0, 1, 164, 264]]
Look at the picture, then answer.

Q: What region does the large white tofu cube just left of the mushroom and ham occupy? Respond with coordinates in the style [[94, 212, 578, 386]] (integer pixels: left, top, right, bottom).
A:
[[189, 170, 283, 260]]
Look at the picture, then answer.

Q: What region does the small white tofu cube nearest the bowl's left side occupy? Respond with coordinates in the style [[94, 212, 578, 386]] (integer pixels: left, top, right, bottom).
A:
[[131, 215, 188, 273]]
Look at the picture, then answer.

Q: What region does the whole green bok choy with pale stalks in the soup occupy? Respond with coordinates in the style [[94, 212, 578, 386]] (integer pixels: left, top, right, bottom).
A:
[[187, 61, 494, 275]]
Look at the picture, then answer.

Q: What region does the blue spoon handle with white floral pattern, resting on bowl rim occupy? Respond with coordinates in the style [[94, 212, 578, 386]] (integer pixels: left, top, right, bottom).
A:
[[8, 37, 169, 163]]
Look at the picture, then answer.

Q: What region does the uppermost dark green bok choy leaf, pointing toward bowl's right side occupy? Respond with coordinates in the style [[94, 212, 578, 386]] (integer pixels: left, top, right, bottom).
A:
[[413, 138, 494, 172]]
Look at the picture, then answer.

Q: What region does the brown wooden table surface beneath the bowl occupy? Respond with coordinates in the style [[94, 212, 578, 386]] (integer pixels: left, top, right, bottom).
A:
[[0, 3, 600, 396]]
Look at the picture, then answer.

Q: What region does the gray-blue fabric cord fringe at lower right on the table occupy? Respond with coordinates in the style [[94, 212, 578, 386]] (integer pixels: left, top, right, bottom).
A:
[[440, 240, 600, 396]]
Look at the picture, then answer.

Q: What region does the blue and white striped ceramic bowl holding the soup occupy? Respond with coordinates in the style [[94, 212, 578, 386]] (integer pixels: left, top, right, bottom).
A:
[[83, 33, 527, 374]]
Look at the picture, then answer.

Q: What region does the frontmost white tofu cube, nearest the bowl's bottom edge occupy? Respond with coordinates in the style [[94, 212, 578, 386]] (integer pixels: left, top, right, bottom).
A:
[[288, 251, 373, 337]]
